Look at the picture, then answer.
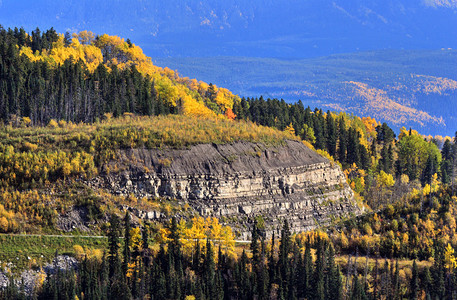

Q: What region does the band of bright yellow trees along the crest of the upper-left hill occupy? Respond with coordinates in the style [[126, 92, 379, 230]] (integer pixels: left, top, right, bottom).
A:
[[20, 31, 240, 119]]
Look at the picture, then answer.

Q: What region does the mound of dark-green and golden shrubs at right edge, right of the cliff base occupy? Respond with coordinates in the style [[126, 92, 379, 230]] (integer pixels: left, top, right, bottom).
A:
[[330, 187, 457, 262]]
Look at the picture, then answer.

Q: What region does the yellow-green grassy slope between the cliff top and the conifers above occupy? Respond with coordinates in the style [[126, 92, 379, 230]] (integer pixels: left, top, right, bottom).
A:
[[0, 115, 296, 152]]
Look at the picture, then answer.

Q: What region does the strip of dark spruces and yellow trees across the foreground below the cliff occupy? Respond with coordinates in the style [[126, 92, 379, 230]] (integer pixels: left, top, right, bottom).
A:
[[4, 211, 457, 299]]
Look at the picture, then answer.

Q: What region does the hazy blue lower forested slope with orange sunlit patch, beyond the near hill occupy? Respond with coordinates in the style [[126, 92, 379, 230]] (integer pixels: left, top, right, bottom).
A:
[[154, 49, 457, 136]]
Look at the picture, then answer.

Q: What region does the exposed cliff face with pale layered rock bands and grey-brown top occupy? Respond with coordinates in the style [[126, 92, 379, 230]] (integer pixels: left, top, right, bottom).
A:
[[91, 141, 359, 238]]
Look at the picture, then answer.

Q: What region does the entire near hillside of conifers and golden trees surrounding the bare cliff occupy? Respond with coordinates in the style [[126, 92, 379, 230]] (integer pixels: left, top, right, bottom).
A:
[[0, 24, 457, 299]]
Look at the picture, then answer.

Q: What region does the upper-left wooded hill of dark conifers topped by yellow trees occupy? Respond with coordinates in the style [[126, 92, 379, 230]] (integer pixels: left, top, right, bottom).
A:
[[0, 27, 238, 125]]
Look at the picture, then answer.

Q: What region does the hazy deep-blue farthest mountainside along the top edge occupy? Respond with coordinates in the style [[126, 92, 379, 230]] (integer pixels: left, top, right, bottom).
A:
[[0, 0, 457, 58]]
